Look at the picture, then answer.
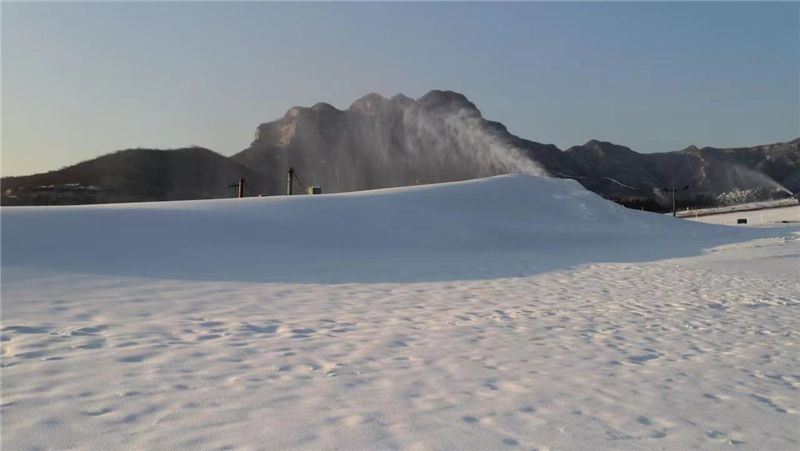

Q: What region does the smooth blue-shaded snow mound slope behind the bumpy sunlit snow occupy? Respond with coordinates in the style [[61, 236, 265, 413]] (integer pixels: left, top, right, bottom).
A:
[[2, 175, 774, 283]]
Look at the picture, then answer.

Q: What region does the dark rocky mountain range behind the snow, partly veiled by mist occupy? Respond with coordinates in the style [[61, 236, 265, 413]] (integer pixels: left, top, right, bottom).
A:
[[0, 90, 800, 210]]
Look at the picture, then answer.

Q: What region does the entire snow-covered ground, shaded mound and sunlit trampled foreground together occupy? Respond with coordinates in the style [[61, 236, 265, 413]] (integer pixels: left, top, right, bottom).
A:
[[0, 176, 800, 449]]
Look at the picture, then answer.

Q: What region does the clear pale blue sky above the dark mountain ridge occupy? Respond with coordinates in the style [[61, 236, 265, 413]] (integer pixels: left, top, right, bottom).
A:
[[2, 2, 800, 175]]
